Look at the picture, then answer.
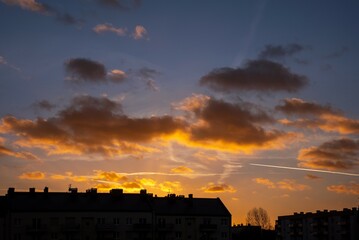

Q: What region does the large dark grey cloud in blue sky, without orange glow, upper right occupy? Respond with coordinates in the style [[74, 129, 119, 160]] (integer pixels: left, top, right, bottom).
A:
[[200, 60, 308, 92]]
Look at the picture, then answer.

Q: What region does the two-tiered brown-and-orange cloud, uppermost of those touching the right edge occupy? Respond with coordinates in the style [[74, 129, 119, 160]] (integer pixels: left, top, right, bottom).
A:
[[276, 98, 359, 134]]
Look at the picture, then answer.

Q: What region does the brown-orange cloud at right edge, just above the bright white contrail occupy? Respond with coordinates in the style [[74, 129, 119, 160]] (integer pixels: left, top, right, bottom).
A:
[[297, 138, 359, 170]]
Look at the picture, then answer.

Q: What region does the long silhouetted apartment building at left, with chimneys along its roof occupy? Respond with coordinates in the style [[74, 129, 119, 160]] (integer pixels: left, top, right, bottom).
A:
[[0, 188, 231, 240]]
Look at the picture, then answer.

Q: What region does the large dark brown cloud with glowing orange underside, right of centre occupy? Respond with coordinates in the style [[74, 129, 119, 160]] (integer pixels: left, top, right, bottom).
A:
[[191, 98, 284, 146]]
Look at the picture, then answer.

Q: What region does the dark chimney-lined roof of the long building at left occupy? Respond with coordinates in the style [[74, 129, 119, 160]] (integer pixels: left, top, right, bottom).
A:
[[0, 189, 231, 217]]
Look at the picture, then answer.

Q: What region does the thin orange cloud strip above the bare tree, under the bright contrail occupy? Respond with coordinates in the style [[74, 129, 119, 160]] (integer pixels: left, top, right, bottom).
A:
[[253, 178, 310, 191]]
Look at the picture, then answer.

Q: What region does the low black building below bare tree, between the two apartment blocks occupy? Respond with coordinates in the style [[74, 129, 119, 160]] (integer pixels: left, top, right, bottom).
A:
[[232, 224, 275, 240]]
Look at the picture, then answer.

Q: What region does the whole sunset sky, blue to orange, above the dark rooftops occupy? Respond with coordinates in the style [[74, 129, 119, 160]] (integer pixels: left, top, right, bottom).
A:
[[0, 0, 359, 224]]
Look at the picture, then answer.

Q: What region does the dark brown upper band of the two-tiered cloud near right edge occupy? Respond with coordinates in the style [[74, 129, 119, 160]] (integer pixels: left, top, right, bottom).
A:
[[275, 98, 338, 115]]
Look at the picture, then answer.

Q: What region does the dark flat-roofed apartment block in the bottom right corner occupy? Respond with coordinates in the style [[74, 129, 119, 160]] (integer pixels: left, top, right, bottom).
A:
[[276, 208, 359, 240]]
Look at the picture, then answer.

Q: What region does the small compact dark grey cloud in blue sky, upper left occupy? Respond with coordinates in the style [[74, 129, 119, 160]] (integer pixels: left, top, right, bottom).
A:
[[65, 58, 106, 82]]
